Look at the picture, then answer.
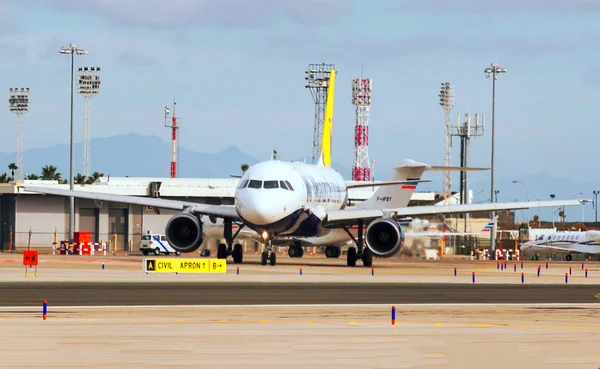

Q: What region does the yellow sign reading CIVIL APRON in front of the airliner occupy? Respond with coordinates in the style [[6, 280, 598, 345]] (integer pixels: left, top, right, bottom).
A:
[[144, 258, 227, 273]]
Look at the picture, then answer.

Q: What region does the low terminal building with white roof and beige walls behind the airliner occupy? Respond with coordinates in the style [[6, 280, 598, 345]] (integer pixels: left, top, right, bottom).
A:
[[0, 177, 496, 251]]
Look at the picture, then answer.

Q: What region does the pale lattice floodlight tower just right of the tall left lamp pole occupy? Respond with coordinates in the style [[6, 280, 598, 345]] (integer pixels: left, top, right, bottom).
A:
[[77, 67, 101, 177]]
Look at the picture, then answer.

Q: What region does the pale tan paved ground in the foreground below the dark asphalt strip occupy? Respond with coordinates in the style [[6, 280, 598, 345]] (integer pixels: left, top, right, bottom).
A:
[[0, 305, 600, 369]]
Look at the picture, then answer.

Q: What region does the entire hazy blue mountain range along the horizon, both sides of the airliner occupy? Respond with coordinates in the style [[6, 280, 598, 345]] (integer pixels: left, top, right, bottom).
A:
[[0, 133, 600, 221]]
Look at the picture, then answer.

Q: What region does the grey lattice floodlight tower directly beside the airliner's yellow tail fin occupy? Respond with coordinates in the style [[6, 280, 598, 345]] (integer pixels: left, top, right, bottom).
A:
[[304, 63, 335, 164]]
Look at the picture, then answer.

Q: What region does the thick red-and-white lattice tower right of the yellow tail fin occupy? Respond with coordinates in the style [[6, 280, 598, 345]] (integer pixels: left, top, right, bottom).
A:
[[352, 78, 371, 181]]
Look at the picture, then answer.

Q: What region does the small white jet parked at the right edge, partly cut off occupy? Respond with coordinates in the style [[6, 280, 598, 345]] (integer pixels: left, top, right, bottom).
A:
[[521, 231, 600, 261]]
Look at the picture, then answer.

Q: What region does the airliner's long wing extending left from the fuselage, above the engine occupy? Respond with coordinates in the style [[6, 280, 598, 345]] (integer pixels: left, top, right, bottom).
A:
[[19, 186, 241, 221]]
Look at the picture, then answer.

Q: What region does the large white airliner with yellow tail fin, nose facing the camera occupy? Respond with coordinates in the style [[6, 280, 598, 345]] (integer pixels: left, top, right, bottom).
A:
[[18, 70, 581, 267]]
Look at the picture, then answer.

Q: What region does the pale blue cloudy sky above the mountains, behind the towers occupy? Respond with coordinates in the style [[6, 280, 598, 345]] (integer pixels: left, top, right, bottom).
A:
[[0, 0, 600, 200]]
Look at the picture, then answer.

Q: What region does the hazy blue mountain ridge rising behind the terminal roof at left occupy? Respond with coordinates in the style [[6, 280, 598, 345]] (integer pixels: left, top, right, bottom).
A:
[[0, 133, 350, 178]]
